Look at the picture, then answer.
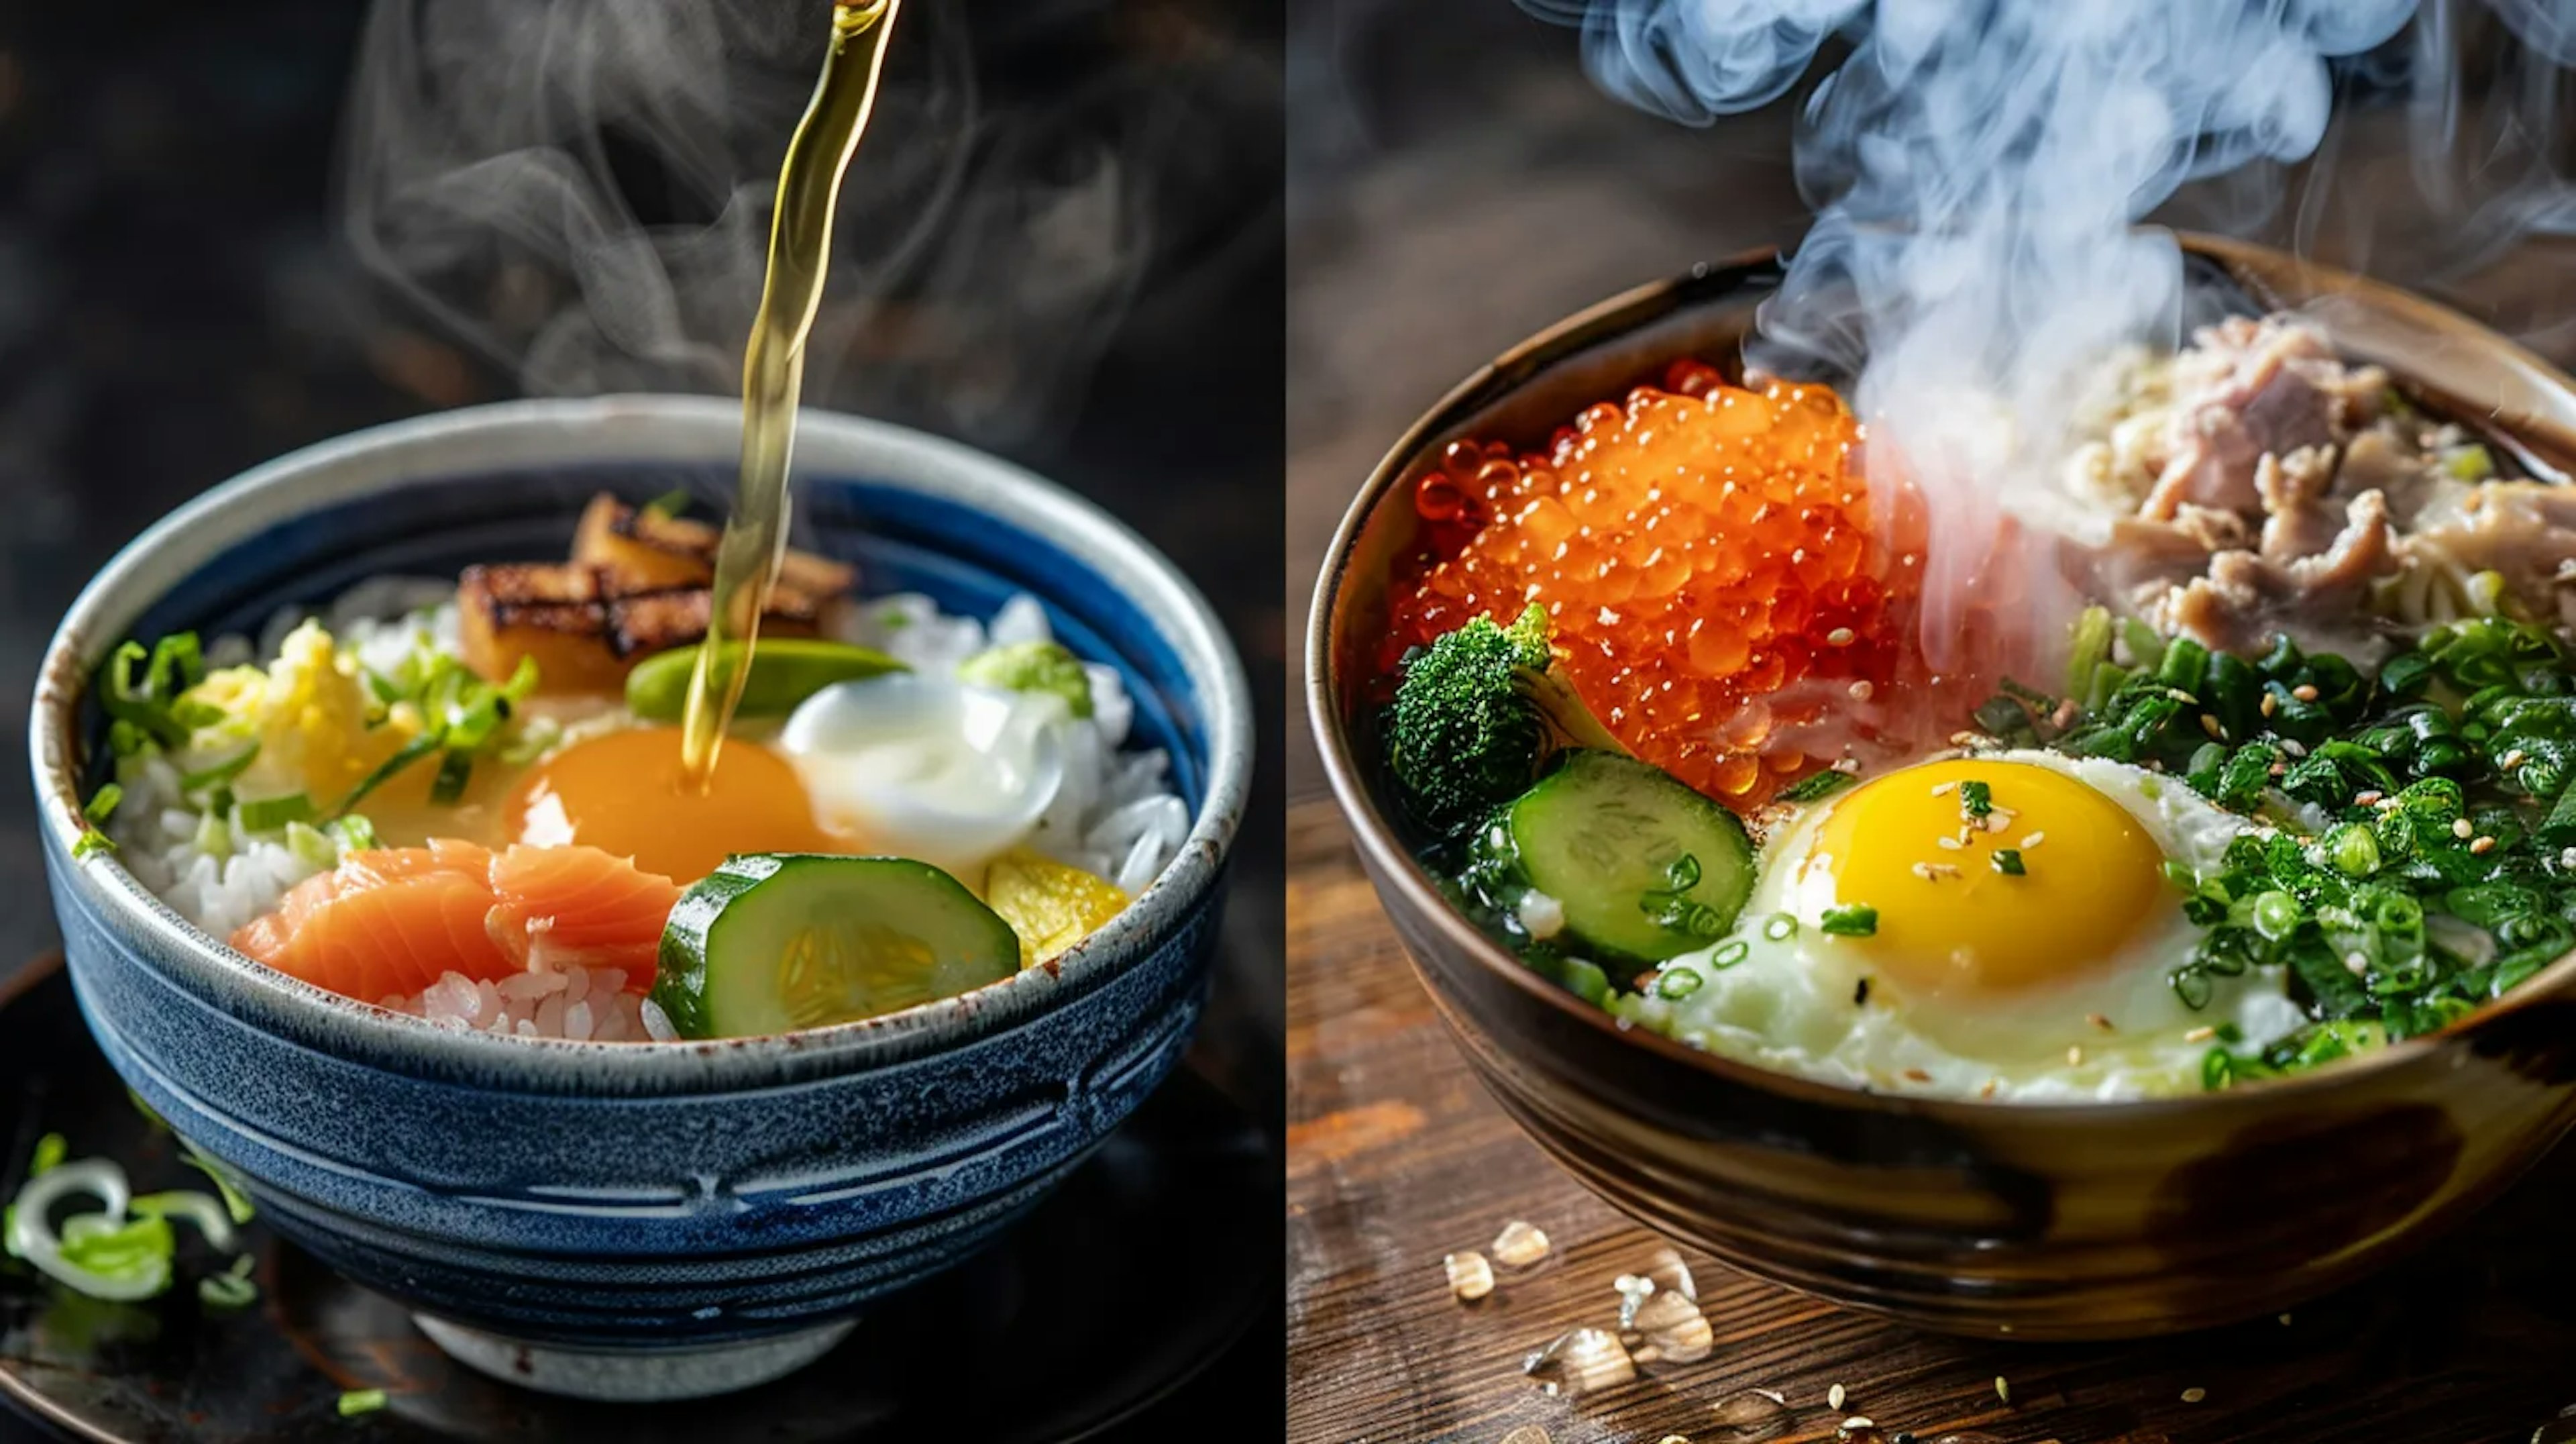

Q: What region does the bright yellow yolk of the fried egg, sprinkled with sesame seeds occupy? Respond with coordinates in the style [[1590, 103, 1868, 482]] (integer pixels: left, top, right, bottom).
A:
[[1806, 758, 2171, 995]]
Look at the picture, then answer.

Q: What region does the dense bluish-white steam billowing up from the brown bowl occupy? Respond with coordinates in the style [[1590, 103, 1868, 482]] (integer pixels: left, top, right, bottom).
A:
[[1530, 0, 2576, 676]]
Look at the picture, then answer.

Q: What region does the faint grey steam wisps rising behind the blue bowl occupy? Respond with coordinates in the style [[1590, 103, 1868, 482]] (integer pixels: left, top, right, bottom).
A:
[[343, 0, 1242, 446]]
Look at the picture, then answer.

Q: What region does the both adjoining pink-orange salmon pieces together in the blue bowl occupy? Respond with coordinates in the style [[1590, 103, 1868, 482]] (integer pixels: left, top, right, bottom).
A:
[[232, 838, 680, 1003]]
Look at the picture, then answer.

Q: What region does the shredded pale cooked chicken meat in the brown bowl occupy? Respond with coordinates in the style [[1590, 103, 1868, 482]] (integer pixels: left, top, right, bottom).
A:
[[2063, 317, 2576, 660]]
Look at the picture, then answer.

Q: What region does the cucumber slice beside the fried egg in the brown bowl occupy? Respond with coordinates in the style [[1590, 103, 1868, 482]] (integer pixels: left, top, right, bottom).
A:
[[1491, 750, 1754, 962]]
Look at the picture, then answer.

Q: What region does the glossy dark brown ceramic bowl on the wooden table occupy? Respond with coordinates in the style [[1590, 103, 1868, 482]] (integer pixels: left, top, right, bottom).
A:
[[1306, 240, 2576, 1338]]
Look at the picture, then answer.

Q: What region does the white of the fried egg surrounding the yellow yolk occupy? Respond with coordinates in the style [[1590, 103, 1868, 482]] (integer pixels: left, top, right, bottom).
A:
[[1613, 750, 2306, 1101]]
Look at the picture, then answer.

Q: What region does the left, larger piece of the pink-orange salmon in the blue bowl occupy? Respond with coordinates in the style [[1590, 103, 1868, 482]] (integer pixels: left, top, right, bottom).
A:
[[232, 848, 521, 1003]]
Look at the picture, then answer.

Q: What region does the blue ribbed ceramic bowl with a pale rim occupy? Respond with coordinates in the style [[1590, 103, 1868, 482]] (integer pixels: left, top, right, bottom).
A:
[[28, 397, 1252, 1398]]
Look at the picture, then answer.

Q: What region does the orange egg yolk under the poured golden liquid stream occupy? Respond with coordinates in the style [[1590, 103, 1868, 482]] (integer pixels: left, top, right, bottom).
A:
[[502, 727, 835, 884]]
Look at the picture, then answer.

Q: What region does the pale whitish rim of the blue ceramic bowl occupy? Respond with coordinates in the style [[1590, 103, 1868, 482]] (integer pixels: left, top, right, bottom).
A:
[[28, 392, 1254, 1091]]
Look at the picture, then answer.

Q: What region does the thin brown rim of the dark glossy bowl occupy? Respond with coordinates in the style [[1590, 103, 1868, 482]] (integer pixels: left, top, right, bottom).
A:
[[1306, 229, 2576, 1127]]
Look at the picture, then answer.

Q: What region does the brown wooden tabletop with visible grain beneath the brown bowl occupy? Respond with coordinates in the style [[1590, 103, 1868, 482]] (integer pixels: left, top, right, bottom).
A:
[[1288, 799, 2576, 1444]]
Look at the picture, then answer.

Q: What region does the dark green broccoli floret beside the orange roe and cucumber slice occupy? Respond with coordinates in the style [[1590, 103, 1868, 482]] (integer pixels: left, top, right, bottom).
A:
[[1386, 606, 1625, 835]]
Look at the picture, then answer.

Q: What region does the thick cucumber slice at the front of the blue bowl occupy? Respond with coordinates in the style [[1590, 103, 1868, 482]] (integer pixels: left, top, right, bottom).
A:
[[652, 854, 1020, 1037]]
